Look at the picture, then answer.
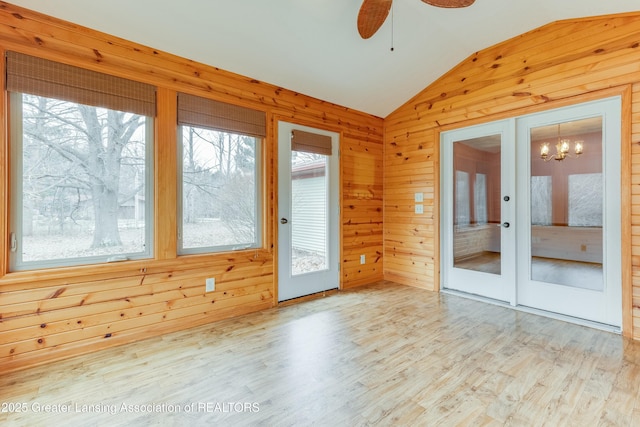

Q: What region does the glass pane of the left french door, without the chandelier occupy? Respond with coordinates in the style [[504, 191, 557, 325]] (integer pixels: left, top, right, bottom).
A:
[[452, 135, 501, 274]]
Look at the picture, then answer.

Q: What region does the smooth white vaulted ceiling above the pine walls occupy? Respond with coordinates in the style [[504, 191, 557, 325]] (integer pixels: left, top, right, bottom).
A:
[[9, 0, 640, 117]]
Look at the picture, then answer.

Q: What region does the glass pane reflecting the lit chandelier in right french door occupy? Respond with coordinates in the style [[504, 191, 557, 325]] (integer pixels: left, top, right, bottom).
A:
[[530, 117, 604, 291]]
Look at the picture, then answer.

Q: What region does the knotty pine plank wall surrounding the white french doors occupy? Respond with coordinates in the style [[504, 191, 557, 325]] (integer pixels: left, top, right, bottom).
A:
[[384, 13, 640, 339]]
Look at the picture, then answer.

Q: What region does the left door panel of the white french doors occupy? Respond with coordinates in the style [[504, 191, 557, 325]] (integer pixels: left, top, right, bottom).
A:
[[441, 120, 516, 303]]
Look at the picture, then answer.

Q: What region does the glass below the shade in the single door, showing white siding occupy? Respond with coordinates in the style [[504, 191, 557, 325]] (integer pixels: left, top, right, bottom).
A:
[[291, 151, 329, 276]]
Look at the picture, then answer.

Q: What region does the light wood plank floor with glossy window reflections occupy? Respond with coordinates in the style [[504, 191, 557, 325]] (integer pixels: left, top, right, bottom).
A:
[[0, 282, 640, 426]]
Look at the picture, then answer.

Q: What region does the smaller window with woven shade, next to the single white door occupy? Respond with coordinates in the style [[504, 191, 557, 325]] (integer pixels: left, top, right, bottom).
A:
[[178, 93, 266, 254]]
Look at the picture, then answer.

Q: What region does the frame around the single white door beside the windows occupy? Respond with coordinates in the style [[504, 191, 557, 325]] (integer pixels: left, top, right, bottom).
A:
[[273, 117, 342, 304]]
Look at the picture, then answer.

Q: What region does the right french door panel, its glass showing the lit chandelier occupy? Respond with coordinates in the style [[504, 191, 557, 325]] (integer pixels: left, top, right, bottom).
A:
[[517, 98, 622, 327]]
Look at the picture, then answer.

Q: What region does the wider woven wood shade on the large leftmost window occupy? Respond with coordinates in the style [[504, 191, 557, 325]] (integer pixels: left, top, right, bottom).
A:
[[6, 52, 156, 117]]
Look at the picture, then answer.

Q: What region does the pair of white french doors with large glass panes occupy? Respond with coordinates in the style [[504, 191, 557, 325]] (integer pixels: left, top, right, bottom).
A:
[[441, 97, 622, 327]]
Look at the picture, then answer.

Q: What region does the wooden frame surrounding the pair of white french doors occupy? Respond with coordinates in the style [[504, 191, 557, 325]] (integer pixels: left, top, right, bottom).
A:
[[434, 94, 634, 332]]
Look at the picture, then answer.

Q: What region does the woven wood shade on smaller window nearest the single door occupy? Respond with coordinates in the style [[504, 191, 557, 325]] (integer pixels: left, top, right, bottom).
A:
[[178, 93, 267, 138]]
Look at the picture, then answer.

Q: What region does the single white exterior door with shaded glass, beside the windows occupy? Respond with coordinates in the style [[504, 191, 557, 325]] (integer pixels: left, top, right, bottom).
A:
[[278, 122, 340, 301]]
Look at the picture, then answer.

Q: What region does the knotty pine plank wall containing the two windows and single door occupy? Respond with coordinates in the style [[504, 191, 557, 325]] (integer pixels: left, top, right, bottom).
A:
[[0, 2, 383, 372]]
